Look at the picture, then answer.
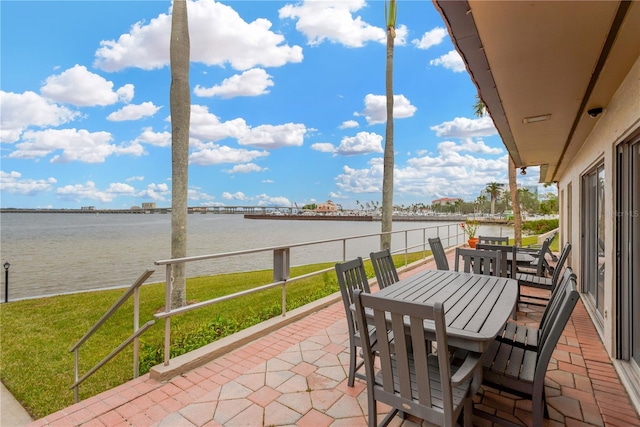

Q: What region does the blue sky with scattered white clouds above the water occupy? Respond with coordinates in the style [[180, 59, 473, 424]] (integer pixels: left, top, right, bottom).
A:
[[0, 0, 538, 209]]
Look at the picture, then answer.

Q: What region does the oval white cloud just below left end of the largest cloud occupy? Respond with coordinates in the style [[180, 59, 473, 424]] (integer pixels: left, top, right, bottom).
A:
[[40, 65, 133, 107]]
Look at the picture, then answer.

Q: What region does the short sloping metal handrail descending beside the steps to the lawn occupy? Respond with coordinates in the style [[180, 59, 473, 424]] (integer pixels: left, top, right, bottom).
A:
[[69, 270, 155, 403]]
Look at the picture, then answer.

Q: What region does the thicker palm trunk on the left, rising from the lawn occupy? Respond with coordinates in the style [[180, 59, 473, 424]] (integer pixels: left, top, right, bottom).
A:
[[169, 0, 191, 308]]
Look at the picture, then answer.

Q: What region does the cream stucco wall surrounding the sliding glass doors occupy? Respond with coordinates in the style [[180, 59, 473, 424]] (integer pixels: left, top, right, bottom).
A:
[[558, 57, 640, 355]]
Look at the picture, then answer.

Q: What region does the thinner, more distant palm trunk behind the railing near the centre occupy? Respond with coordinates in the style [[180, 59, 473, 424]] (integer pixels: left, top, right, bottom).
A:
[[380, 0, 396, 249]]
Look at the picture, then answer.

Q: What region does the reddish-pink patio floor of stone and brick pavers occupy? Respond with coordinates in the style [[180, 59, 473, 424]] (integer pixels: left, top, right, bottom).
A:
[[30, 252, 640, 427]]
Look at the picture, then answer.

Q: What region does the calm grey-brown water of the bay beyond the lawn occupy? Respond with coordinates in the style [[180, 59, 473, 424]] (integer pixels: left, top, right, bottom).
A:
[[0, 213, 510, 301]]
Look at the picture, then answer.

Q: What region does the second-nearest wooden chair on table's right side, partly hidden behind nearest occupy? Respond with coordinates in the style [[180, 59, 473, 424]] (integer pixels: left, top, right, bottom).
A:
[[496, 267, 576, 350]]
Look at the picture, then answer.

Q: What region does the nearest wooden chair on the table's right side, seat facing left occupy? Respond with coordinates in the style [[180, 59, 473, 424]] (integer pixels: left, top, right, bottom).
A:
[[474, 277, 580, 427]]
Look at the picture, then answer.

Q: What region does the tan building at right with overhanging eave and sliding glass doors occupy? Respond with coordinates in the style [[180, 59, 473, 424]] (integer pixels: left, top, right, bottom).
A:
[[434, 0, 640, 409]]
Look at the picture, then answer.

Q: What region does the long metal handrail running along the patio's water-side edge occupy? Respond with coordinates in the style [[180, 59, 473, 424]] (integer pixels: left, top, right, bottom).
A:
[[154, 224, 463, 366]]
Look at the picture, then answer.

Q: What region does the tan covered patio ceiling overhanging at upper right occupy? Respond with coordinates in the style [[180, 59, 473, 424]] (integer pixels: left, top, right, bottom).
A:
[[434, 0, 640, 182]]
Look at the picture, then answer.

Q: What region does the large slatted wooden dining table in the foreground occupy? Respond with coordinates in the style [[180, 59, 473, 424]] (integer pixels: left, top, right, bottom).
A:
[[376, 270, 518, 352]]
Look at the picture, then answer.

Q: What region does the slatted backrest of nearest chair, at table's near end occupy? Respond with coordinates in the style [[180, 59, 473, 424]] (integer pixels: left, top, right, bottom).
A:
[[355, 291, 456, 426]]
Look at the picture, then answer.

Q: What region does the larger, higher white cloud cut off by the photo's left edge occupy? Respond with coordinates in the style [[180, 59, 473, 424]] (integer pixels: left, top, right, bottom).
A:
[[0, 91, 80, 142]]
